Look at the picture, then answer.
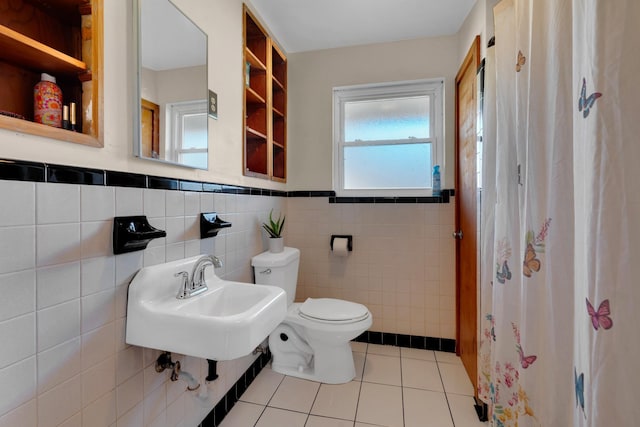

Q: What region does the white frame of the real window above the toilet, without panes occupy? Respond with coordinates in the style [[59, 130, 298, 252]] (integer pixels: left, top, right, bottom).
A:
[[333, 78, 444, 197]]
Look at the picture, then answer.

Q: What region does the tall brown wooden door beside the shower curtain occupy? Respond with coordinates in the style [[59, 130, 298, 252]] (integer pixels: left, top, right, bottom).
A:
[[454, 36, 480, 395]]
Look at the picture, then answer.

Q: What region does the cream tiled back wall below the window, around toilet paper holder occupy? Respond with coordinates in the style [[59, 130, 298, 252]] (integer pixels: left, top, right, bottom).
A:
[[286, 198, 455, 338]]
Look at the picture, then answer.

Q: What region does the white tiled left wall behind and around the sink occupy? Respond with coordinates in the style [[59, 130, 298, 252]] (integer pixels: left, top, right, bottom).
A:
[[0, 181, 286, 427]]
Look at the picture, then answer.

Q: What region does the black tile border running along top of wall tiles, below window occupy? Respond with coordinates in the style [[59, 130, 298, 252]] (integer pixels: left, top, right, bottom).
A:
[[0, 158, 455, 204]]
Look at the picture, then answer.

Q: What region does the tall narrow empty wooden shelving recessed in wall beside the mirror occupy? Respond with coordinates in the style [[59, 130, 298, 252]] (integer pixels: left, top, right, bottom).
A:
[[243, 5, 287, 182]]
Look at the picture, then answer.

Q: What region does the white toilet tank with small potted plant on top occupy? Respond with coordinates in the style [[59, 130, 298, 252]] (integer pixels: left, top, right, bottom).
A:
[[251, 247, 300, 305]]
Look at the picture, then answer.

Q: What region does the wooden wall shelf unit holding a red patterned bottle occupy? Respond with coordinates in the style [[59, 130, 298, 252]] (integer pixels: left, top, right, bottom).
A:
[[0, 0, 103, 147]]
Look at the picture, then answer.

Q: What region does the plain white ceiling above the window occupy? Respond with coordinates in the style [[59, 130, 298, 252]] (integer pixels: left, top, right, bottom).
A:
[[251, 0, 476, 53]]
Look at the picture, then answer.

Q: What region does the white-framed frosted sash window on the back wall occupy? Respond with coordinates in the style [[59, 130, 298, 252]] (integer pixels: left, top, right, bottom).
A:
[[333, 80, 443, 196]]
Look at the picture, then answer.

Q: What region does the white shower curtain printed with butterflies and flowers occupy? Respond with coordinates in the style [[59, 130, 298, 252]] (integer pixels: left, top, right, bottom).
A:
[[477, 0, 640, 427]]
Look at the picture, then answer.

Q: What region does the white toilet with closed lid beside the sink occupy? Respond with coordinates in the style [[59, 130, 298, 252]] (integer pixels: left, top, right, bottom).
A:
[[251, 247, 372, 384]]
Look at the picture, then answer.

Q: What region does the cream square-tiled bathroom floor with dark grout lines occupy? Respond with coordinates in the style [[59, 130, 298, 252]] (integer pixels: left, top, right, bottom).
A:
[[222, 343, 487, 427]]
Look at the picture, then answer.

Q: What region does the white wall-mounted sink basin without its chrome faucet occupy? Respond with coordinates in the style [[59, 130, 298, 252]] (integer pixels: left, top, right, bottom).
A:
[[126, 256, 287, 360]]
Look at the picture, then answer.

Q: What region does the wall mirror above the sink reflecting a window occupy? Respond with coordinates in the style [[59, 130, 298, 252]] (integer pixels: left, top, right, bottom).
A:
[[133, 0, 209, 169]]
